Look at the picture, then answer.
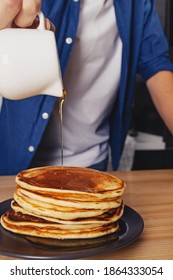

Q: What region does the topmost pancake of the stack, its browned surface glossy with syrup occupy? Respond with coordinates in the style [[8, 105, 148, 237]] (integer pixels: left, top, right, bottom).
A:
[[16, 166, 124, 194]]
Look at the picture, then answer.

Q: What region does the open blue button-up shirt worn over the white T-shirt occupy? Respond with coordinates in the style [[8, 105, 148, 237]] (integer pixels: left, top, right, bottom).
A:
[[0, 0, 173, 175]]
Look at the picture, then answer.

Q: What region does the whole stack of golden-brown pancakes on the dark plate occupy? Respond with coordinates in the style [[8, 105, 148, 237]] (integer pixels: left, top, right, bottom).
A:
[[1, 166, 125, 239]]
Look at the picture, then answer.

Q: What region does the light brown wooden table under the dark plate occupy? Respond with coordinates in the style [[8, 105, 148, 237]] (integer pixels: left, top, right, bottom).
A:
[[0, 170, 173, 260]]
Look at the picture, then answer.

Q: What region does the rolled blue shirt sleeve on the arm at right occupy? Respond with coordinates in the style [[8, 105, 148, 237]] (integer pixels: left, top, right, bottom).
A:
[[138, 0, 173, 81]]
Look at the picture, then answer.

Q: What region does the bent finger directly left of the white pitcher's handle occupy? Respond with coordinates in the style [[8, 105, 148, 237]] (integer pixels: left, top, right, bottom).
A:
[[14, 0, 41, 28]]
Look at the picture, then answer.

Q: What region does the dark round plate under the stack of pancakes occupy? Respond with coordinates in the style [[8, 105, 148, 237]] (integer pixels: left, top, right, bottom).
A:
[[0, 199, 144, 260]]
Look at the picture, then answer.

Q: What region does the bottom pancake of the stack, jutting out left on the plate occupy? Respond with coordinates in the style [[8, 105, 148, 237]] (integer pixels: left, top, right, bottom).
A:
[[1, 209, 119, 239]]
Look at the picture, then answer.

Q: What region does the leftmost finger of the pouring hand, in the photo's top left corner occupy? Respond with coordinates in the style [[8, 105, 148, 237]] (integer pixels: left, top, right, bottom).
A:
[[0, 0, 23, 29]]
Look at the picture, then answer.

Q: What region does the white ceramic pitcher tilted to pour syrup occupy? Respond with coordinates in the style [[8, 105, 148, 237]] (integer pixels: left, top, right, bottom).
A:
[[0, 12, 63, 100]]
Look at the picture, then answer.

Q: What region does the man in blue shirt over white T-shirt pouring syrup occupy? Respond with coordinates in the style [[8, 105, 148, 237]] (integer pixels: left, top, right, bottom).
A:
[[0, 0, 173, 174]]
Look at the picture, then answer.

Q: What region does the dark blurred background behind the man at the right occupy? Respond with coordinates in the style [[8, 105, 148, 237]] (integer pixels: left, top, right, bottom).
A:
[[128, 0, 173, 170]]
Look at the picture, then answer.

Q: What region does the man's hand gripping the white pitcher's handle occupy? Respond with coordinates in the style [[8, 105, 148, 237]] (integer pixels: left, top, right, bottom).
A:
[[0, 0, 54, 31]]
